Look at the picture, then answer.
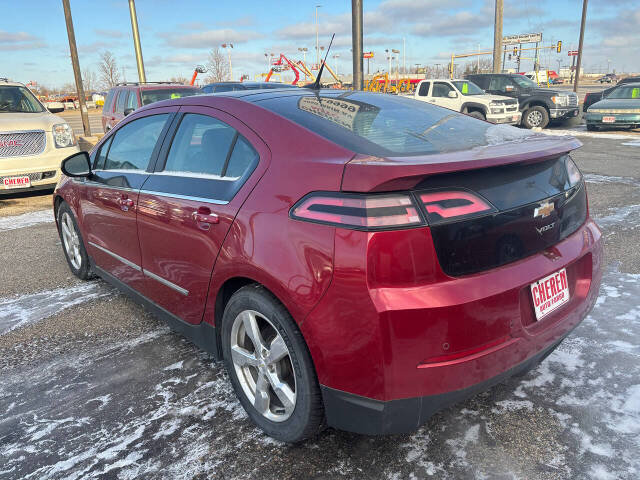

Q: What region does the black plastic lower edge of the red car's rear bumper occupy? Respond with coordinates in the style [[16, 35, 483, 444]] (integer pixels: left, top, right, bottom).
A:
[[320, 331, 571, 435]]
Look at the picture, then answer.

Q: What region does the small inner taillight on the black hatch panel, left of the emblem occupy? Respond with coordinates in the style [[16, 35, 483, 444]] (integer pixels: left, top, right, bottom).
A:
[[418, 190, 497, 225]]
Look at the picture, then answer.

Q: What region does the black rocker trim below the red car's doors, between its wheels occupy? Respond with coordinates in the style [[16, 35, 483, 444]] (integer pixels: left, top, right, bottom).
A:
[[89, 258, 222, 361]]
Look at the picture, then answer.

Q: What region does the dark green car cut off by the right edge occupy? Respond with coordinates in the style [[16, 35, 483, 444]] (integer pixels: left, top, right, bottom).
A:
[[586, 83, 640, 130]]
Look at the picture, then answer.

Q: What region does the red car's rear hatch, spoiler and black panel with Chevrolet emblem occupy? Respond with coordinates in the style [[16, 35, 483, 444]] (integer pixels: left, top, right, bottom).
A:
[[343, 136, 587, 276]]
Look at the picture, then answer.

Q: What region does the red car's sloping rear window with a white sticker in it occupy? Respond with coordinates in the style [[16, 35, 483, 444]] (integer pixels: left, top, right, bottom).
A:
[[256, 92, 510, 157]]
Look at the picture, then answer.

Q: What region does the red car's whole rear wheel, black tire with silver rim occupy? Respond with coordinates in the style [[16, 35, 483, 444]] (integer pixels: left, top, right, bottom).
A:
[[221, 284, 325, 443]]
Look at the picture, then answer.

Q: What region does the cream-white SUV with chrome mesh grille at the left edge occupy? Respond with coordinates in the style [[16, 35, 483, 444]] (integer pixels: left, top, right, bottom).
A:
[[0, 78, 78, 196]]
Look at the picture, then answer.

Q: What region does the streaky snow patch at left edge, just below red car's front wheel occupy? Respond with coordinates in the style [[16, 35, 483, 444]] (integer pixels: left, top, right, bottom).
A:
[[0, 281, 115, 335]]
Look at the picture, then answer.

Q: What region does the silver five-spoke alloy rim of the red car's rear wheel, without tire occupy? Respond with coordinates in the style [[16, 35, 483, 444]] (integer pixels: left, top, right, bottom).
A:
[[231, 310, 297, 422]]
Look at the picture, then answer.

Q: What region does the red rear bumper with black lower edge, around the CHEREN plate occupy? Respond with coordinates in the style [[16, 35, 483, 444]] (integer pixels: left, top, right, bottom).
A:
[[312, 219, 602, 434]]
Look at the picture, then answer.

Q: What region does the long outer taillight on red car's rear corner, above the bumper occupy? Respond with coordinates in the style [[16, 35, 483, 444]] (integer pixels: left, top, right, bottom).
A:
[[291, 193, 424, 230]]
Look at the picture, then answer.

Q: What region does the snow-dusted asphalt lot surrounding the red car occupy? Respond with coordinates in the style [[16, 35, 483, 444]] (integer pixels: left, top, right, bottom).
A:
[[0, 130, 640, 480]]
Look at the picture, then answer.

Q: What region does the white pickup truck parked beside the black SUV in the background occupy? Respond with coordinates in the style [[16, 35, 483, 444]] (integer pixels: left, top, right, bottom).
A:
[[414, 78, 522, 125]]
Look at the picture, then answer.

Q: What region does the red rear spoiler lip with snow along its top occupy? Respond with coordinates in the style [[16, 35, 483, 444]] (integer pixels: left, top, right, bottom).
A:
[[341, 135, 582, 192]]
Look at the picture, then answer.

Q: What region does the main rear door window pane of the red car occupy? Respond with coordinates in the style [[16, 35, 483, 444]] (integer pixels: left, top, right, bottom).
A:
[[164, 113, 236, 175]]
